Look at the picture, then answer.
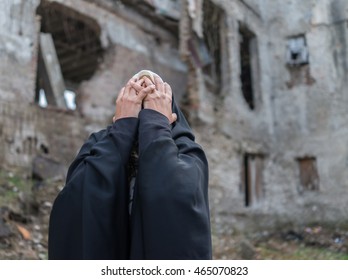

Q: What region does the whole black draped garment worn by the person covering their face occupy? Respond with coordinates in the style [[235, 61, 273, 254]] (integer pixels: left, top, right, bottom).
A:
[[49, 100, 211, 259]]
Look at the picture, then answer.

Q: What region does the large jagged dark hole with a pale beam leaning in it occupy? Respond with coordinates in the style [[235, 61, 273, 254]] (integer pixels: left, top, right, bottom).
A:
[[35, 1, 103, 110]]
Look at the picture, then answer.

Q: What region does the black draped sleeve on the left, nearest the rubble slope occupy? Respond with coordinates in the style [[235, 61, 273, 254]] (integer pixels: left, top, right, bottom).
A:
[[49, 118, 138, 259]]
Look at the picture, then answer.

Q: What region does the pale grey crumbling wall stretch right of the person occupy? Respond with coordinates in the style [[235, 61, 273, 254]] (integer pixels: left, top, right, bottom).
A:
[[180, 0, 348, 235]]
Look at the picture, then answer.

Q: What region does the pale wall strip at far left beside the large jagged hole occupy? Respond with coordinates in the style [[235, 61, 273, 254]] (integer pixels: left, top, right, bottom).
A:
[[0, 0, 39, 103]]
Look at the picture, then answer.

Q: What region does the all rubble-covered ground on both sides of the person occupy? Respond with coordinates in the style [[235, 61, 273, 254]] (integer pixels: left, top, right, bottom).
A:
[[0, 167, 348, 260]]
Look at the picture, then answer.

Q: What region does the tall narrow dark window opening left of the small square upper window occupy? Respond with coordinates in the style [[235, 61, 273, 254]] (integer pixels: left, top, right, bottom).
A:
[[239, 23, 259, 110]]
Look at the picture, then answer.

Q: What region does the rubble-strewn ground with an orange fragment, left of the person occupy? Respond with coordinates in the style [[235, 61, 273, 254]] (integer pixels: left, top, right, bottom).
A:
[[0, 171, 63, 260]]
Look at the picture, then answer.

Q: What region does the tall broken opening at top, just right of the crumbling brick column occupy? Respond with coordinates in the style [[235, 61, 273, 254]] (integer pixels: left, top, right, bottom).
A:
[[203, 0, 227, 94]]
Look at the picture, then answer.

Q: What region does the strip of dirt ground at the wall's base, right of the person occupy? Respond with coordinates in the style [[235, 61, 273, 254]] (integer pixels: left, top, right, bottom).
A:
[[214, 225, 348, 260]]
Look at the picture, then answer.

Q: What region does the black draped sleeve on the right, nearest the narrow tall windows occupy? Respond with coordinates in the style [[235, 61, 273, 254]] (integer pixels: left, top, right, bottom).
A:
[[131, 110, 212, 259]]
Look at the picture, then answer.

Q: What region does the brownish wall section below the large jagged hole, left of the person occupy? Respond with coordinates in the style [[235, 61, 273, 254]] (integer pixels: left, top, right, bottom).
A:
[[0, 101, 86, 171]]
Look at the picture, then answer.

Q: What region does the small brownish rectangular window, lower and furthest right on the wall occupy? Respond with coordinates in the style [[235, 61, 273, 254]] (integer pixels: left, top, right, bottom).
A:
[[297, 157, 319, 192]]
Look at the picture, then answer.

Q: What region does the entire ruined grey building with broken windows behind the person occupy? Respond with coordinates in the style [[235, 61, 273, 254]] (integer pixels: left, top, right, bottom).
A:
[[0, 0, 348, 243]]
